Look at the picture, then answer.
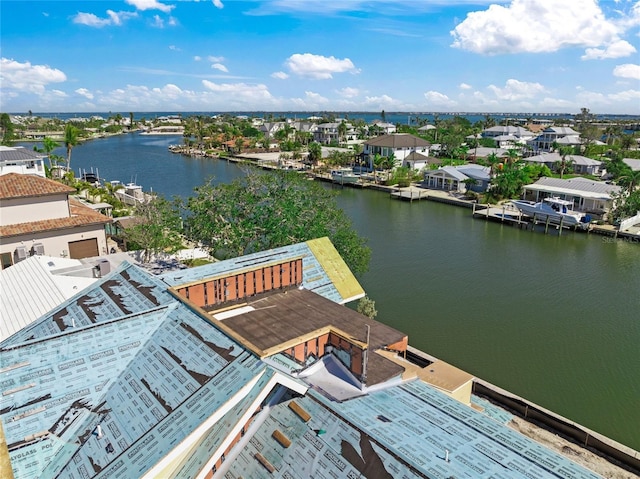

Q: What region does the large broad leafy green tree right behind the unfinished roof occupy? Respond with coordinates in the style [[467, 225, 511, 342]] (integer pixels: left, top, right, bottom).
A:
[[186, 171, 371, 274]]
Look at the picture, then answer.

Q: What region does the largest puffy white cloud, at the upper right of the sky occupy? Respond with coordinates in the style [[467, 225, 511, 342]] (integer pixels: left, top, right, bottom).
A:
[[451, 0, 620, 55]]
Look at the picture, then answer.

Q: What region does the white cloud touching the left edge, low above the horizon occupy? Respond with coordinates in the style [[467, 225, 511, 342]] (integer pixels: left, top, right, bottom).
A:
[[0, 58, 67, 95]]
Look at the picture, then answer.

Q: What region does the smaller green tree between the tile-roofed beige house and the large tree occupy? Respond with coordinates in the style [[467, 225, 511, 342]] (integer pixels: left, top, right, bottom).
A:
[[124, 196, 183, 263]]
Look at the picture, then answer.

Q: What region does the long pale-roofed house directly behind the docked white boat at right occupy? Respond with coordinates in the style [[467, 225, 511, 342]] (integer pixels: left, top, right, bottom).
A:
[[524, 177, 621, 216]]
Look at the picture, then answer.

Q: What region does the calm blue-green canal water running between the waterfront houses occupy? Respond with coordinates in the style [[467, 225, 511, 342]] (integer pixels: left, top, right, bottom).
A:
[[47, 134, 640, 450]]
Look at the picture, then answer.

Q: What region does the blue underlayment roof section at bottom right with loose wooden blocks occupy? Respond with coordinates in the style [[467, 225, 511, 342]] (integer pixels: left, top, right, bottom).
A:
[[222, 380, 600, 479]]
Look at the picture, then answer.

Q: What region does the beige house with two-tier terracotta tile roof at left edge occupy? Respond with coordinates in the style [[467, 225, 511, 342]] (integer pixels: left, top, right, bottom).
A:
[[0, 173, 111, 268]]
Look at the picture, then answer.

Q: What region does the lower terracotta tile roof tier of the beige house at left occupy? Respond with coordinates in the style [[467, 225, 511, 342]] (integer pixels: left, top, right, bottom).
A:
[[0, 197, 112, 238]]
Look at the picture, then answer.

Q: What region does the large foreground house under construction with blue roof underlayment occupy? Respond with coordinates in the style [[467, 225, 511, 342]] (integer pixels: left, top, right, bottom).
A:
[[0, 238, 610, 479]]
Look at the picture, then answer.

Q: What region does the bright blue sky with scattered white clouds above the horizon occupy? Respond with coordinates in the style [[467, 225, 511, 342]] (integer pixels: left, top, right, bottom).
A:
[[0, 0, 640, 115]]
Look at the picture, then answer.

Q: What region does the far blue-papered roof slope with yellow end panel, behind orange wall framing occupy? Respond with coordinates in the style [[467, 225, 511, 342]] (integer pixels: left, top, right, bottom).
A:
[[160, 237, 364, 304]]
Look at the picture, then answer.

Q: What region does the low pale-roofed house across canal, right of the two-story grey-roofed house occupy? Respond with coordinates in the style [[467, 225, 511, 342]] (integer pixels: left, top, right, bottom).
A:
[[424, 163, 491, 193]]
